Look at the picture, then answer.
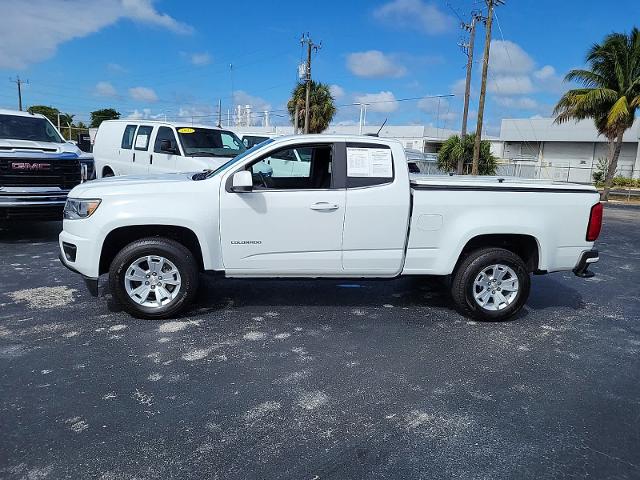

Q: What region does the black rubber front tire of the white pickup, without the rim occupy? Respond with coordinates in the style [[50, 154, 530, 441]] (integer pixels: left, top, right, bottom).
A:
[[109, 237, 199, 320]]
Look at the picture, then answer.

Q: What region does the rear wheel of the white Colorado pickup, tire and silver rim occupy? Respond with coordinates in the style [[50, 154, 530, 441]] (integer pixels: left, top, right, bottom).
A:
[[451, 248, 531, 321]]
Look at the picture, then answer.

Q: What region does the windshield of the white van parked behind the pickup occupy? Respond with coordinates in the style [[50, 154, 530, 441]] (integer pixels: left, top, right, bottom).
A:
[[177, 127, 246, 157]]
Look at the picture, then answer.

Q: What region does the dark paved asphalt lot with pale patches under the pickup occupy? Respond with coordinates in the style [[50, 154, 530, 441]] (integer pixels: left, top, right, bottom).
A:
[[0, 207, 640, 480]]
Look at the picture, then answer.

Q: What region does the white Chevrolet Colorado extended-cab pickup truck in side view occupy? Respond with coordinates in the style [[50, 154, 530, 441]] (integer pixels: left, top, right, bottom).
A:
[[60, 135, 602, 320]]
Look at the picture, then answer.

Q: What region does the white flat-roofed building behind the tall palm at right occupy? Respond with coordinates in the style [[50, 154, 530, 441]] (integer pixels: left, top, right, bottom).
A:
[[499, 118, 640, 182]]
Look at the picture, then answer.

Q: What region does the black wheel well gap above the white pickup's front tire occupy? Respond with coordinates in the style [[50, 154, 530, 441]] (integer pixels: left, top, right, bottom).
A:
[[99, 225, 204, 274]]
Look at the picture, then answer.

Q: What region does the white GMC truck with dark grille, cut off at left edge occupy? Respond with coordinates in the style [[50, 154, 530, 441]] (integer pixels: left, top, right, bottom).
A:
[[0, 109, 95, 220]]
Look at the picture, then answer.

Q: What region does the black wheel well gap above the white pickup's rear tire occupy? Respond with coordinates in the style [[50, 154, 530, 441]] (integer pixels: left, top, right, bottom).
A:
[[456, 233, 540, 272]]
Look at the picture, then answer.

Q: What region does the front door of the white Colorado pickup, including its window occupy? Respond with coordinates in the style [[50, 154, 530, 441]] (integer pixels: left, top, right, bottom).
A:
[[220, 143, 348, 276]]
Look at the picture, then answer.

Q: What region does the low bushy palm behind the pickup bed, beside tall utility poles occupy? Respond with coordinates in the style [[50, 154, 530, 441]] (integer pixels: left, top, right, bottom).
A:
[[438, 133, 497, 175]]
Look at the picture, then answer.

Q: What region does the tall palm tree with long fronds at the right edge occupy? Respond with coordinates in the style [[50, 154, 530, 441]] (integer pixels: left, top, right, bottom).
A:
[[553, 28, 640, 201]]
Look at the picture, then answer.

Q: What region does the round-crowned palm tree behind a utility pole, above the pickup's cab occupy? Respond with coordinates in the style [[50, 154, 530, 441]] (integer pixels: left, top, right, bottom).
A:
[[287, 80, 336, 133]]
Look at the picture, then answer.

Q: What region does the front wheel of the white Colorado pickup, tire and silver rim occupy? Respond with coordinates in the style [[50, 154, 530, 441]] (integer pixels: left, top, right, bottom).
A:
[[109, 237, 198, 319]]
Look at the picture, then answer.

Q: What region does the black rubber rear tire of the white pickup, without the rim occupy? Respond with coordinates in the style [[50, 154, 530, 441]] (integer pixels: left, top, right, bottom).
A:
[[451, 248, 531, 321]]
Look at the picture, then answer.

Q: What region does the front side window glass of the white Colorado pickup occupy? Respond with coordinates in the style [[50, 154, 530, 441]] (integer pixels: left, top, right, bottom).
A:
[[249, 145, 333, 190]]
